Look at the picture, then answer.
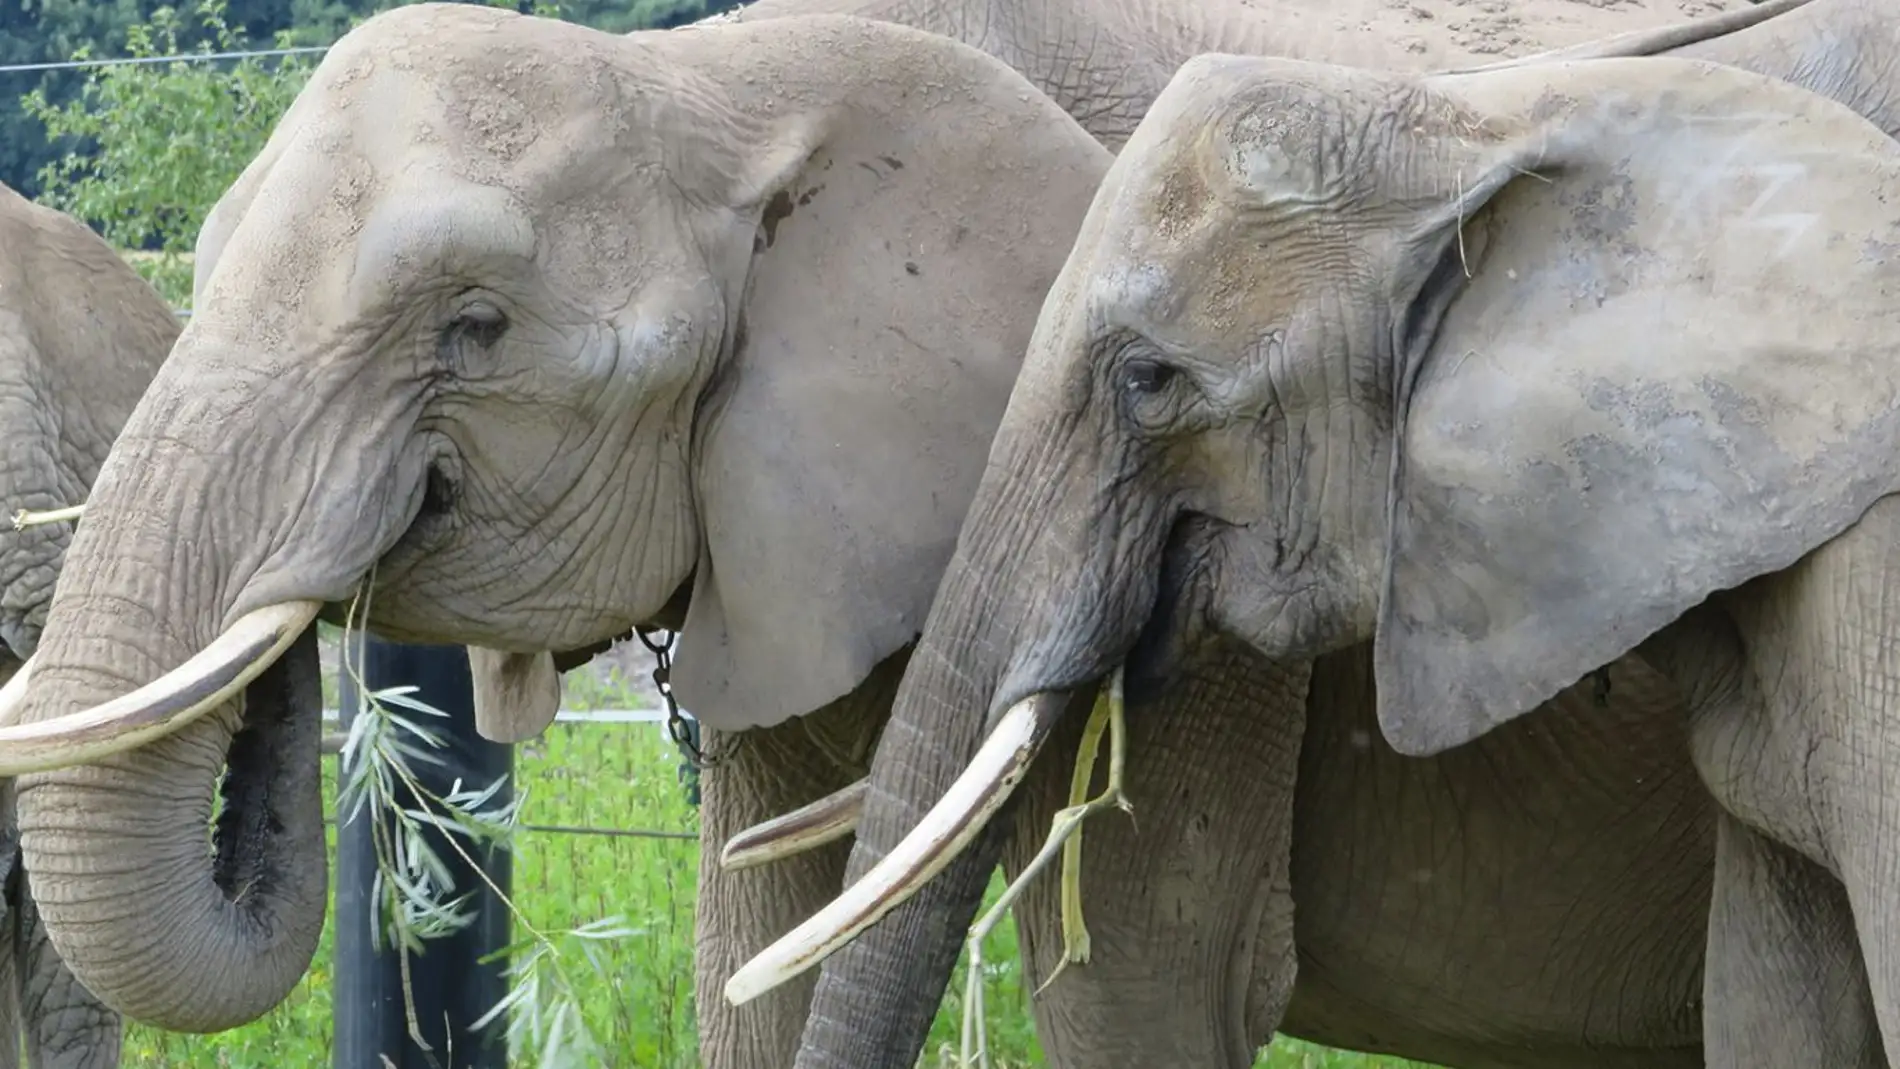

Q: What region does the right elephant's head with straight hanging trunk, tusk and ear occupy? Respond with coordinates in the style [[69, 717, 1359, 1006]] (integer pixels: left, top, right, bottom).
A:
[[728, 55, 1900, 1067]]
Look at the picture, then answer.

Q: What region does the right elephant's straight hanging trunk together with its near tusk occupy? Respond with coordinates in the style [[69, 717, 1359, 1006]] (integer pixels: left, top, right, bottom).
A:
[[763, 423, 1165, 1069]]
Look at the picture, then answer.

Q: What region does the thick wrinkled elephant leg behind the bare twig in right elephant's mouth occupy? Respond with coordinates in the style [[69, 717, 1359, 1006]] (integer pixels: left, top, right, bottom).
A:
[[1003, 642, 1307, 1069]]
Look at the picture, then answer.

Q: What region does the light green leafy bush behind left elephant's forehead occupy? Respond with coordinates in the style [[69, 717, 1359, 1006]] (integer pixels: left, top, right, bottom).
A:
[[21, 0, 314, 304]]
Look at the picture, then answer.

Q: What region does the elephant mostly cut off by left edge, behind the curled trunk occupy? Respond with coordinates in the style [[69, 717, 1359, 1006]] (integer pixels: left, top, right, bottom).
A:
[[0, 186, 179, 1069]]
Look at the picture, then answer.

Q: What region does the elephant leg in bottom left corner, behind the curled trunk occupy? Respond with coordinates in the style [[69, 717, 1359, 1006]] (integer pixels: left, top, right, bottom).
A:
[[13, 866, 124, 1069]]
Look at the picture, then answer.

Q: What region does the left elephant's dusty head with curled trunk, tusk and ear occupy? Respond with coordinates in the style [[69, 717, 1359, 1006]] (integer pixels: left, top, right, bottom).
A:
[[0, 4, 1108, 1031]]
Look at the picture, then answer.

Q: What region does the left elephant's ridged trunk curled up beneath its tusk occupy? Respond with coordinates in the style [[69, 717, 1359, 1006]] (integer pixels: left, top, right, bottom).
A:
[[8, 372, 327, 1033]]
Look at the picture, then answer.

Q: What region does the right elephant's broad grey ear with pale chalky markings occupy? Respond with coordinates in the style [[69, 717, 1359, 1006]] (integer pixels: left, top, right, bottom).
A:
[[1376, 59, 1900, 754]]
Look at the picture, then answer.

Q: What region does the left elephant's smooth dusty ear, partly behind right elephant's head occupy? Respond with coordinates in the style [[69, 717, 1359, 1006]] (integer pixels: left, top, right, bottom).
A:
[[673, 17, 1110, 729]]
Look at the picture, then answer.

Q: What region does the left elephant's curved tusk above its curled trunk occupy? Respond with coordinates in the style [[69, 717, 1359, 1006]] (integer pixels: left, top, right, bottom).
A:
[[0, 602, 323, 777]]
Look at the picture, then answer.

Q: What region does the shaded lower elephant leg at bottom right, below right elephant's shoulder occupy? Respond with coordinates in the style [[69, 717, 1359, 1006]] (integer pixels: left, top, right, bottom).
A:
[[1702, 815, 1887, 1069]]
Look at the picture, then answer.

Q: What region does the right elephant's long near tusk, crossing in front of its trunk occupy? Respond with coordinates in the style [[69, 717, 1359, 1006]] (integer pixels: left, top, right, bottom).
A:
[[726, 693, 1068, 1006]]
